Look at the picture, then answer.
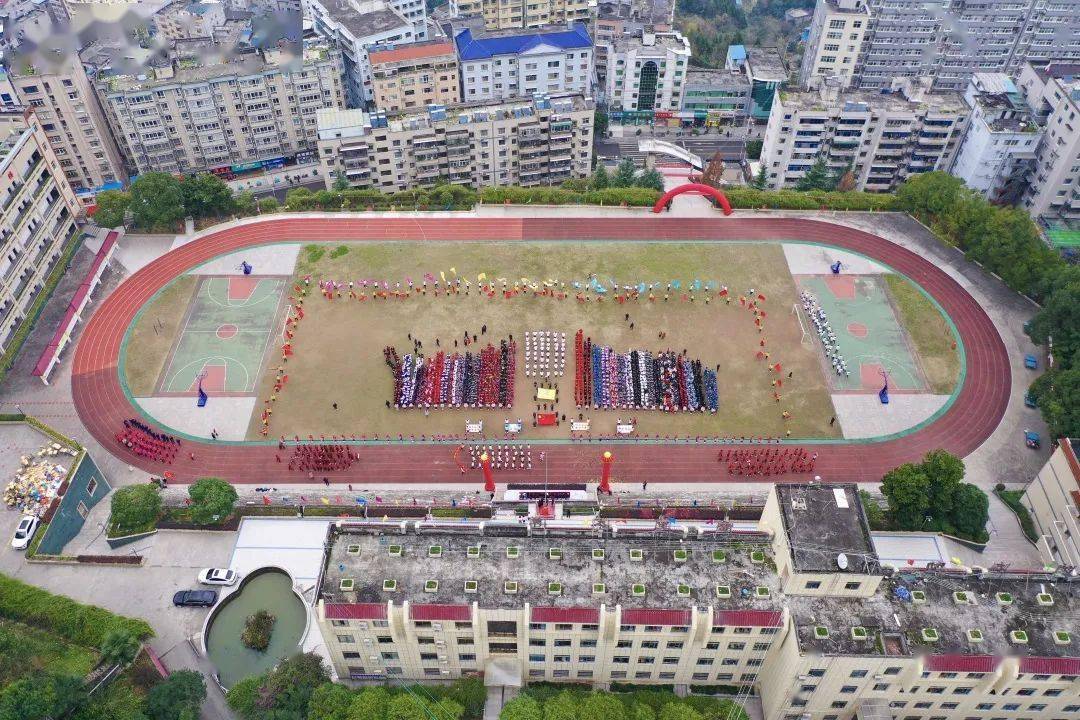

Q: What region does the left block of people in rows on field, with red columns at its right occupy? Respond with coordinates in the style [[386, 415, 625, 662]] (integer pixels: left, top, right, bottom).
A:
[[382, 340, 517, 410]]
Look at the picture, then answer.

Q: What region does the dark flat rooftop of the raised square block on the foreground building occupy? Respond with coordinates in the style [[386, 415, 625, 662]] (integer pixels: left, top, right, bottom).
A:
[[777, 484, 878, 574]]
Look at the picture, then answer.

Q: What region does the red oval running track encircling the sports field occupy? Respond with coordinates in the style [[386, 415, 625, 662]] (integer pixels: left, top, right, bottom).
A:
[[71, 217, 1011, 485]]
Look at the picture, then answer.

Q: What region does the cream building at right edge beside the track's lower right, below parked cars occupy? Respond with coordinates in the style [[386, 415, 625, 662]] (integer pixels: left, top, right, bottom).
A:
[[1021, 437, 1080, 569]]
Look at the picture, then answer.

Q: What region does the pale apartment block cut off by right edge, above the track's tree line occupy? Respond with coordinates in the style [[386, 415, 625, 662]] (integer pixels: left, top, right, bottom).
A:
[[1017, 63, 1080, 219]]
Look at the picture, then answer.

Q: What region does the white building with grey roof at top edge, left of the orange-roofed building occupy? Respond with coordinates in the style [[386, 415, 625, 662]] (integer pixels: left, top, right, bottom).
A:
[[305, 0, 428, 108]]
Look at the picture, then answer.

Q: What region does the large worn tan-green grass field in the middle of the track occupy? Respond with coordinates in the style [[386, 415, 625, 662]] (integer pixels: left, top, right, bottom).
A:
[[248, 242, 838, 439]]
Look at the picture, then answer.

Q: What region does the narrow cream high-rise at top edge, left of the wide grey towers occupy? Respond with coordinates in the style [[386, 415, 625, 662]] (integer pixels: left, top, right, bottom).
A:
[[799, 0, 870, 87]]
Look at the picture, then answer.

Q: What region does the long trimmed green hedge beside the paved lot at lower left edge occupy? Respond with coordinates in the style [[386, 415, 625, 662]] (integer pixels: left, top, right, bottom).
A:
[[0, 574, 153, 648]]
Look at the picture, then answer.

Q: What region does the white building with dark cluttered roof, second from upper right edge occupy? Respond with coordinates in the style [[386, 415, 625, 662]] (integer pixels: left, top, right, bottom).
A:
[[949, 72, 1042, 204]]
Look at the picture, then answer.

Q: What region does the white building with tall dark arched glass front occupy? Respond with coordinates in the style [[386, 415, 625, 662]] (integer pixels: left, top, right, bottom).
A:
[[599, 31, 690, 112]]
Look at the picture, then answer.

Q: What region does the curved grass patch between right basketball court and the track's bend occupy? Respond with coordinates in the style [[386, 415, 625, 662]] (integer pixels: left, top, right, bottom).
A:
[[885, 274, 960, 395]]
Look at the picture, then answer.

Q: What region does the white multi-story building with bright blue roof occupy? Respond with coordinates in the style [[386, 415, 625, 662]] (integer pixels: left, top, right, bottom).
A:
[[454, 23, 594, 103]]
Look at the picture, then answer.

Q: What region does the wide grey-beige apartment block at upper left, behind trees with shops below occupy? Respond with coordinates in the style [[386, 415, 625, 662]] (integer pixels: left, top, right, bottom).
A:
[[98, 42, 345, 174]]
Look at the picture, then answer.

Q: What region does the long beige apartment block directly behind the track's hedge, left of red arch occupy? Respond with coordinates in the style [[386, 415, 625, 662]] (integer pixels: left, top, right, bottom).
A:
[[319, 95, 595, 192]]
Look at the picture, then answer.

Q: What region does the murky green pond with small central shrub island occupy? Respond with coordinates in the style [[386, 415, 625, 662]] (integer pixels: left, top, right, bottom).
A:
[[205, 569, 308, 688]]
